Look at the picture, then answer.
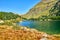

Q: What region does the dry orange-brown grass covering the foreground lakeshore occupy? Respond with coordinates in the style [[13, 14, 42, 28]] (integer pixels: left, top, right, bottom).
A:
[[0, 25, 60, 40]]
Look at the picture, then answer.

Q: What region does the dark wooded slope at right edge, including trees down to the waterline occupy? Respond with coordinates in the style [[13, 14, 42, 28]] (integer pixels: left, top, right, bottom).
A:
[[49, 0, 60, 20]]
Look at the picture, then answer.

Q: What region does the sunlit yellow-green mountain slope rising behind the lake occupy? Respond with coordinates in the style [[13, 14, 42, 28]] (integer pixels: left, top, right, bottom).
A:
[[22, 0, 57, 19]]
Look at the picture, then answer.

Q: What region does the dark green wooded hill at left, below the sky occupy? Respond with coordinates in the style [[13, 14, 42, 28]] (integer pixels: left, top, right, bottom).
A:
[[0, 12, 20, 20]]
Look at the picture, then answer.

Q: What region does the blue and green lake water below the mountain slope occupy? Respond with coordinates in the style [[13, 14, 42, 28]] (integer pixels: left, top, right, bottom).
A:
[[19, 21, 60, 34]]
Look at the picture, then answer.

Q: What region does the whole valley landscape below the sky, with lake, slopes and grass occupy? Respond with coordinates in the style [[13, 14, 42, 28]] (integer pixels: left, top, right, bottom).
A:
[[0, 0, 60, 40]]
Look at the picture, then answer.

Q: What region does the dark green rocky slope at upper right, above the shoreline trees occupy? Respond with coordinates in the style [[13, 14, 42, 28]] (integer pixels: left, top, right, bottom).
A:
[[50, 0, 60, 16]]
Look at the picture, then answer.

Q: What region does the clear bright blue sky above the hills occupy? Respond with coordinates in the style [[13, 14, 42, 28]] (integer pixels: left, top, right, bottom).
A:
[[0, 0, 41, 14]]
